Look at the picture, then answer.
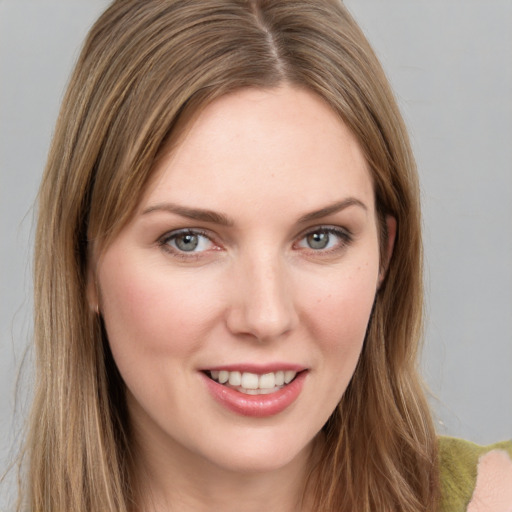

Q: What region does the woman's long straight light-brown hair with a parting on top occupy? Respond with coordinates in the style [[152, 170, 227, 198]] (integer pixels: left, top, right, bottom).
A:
[[24, 0, 438, 512]]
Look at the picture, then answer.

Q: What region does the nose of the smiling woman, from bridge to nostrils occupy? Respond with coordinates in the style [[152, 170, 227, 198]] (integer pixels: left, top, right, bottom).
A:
[[227, 251, 298, 341]]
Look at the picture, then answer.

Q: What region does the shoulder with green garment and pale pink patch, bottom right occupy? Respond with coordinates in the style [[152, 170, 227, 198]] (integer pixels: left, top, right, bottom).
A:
[[439, 437, 512, 512]]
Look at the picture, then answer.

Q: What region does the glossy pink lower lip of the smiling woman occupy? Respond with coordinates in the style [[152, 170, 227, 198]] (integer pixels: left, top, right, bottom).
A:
[[202, 371, 307, 418]]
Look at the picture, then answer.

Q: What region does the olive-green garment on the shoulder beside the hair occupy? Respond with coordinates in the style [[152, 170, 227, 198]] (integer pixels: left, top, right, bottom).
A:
[[439, 437, 512, 512]]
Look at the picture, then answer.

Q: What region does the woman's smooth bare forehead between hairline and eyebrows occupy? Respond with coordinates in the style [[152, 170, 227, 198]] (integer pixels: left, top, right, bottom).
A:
[[141, 86, 373, 213]]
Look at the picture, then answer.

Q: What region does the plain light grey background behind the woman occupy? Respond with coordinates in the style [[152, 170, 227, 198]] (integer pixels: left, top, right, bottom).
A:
[[0, 0, 512, 508]]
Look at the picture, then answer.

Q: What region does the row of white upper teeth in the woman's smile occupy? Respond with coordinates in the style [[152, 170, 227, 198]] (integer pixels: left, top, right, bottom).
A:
[[210, 370, 297, 395]]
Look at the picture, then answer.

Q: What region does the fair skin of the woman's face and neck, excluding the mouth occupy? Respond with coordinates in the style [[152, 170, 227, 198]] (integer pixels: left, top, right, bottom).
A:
[[89, 86, 395, 512]]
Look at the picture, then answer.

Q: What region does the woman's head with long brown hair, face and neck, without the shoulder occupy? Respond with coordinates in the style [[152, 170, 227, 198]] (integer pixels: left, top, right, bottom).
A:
[[18, 0, 510, 511]]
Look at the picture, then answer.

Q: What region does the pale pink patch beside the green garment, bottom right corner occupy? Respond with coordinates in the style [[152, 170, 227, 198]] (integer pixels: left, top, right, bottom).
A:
[[467, 450, 512, 512]]
